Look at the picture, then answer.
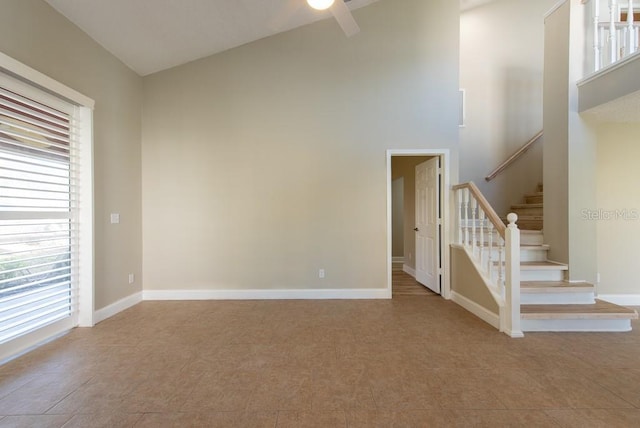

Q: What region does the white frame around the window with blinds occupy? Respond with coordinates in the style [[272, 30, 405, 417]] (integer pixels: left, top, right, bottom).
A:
[[0, 52, 95, 361]]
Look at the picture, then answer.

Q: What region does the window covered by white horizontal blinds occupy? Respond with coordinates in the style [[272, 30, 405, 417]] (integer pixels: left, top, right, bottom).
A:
[[0, 86, 77, 344]]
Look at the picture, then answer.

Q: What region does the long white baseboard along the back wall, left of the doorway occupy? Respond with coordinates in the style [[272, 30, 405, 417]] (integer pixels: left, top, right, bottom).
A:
[[142, 288, 391, 300]]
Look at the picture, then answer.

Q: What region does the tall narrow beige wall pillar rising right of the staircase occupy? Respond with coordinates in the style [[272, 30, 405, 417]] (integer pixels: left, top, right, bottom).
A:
[[543, 0, 598, 282]]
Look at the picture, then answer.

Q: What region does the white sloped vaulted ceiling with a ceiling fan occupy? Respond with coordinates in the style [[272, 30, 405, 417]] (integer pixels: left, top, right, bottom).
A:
[[45, 0, 492, 76]]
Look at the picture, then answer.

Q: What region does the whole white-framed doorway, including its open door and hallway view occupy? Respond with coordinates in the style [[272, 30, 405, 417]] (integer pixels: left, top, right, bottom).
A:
[[387, 149, 450, 299]]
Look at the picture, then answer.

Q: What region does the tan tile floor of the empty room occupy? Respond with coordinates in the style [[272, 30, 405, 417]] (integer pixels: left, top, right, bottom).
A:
[[0, 296, 640, 428]]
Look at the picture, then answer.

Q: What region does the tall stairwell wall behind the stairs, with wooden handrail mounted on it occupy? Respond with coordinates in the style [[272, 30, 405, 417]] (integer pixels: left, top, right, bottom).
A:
[[460, 0, 557, 215]]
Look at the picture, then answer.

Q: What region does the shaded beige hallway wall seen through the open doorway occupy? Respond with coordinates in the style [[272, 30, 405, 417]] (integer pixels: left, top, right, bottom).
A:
[[391, 156, 431, 269]]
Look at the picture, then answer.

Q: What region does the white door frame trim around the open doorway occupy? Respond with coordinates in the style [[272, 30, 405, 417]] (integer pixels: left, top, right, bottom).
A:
[[387, 149, 451, 300]]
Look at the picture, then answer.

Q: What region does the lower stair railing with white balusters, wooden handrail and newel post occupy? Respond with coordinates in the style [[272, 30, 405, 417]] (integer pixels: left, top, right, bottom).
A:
[[453, 182, 522, 337]]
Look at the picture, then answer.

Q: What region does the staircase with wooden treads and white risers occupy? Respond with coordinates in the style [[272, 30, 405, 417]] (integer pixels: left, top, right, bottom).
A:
[[511, 185, 638, 332]]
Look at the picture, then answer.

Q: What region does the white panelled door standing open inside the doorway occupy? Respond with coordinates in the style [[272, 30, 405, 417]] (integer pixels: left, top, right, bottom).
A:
[[414, 157, 440, 294]]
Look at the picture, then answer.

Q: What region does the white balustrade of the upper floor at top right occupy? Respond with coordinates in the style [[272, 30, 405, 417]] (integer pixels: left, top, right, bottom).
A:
[[583, 0, 640, 74]]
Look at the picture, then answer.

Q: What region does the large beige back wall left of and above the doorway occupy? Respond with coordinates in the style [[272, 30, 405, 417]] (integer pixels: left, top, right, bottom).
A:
[[142, 0, 459, 290]]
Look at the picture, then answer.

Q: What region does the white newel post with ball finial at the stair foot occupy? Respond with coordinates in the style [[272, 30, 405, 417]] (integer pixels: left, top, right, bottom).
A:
[[504, 213, 524, 337]]
